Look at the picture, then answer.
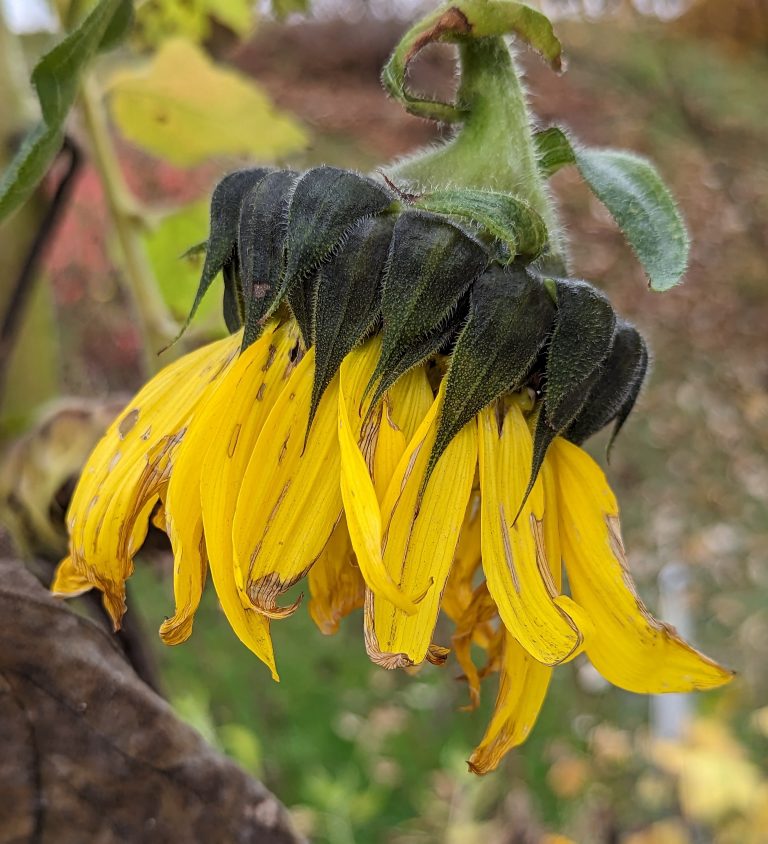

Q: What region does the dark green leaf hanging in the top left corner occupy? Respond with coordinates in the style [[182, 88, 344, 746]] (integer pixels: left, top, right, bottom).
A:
[[0, 0, 133, 220]]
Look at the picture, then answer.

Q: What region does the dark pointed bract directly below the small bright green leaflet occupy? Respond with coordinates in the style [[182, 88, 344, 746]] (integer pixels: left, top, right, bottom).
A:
[[376, 211, 489, 376]]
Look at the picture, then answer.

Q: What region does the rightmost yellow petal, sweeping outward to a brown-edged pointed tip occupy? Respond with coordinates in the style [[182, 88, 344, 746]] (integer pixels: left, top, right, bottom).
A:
[[547, 438, 732, 694]]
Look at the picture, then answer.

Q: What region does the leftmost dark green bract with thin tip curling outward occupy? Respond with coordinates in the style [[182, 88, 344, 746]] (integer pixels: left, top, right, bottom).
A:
[[187, 167, 270, 325]]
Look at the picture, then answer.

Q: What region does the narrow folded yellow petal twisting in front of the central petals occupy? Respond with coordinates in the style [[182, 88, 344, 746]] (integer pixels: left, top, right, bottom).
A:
[[338, 347, 416, 613]]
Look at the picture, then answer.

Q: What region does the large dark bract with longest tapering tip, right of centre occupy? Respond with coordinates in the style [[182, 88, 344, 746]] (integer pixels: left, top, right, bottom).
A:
[[427, 266, 555, 477]]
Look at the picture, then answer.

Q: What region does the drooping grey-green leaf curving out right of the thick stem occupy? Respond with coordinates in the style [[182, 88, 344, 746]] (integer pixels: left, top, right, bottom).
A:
[[536, 127, 690, 291]]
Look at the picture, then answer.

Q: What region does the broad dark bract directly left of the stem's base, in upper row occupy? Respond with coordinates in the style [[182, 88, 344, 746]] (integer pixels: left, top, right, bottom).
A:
[[285, 166, 393, 290]]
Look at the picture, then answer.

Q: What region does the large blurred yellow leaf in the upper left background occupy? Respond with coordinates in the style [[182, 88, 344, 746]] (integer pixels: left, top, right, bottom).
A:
[[109, 38, 307, 167]]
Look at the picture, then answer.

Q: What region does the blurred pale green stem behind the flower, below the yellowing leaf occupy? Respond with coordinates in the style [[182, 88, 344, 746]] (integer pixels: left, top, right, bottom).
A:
[[81, 78, 178, 372]]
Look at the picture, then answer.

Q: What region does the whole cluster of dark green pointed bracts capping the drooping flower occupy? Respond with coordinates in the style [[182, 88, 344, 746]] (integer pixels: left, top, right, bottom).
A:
[[190, 166, 648, 502]]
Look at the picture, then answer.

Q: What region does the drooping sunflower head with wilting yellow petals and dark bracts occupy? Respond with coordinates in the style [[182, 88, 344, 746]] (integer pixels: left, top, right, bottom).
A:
[[53, 162, 731, 773]]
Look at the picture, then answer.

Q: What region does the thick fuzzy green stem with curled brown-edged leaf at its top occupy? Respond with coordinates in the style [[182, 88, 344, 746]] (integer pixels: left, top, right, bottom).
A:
[[382, 0, 565, 263]]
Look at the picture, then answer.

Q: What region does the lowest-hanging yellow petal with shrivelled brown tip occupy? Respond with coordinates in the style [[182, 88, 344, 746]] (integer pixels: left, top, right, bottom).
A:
[[469, 633, 552, 774]]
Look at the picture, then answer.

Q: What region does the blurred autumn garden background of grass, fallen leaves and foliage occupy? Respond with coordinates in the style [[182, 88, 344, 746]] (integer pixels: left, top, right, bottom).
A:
[[0, 0, 768, 844]]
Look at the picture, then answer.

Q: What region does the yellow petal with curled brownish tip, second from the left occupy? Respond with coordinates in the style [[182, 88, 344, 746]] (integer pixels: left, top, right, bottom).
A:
[[160, 323, 280, 645]]
